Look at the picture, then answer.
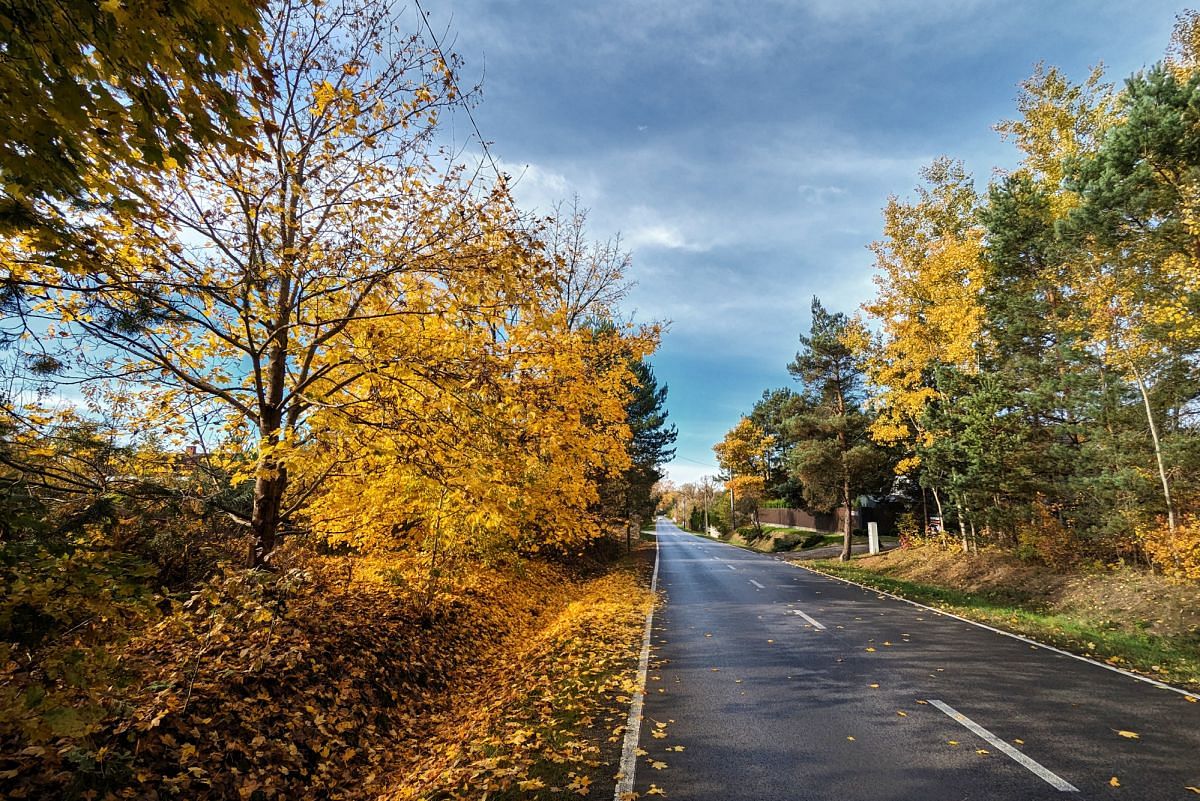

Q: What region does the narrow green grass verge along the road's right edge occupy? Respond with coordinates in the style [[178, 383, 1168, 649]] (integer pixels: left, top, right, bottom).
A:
[[805, 560, 1200, 691]]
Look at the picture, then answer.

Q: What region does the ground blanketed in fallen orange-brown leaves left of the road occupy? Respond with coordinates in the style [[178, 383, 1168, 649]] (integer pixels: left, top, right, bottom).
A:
[[0, 546, 650, 801]]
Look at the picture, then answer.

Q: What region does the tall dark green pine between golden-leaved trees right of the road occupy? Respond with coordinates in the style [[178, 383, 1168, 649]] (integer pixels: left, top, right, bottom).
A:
[[966, 174, 1106, 531]]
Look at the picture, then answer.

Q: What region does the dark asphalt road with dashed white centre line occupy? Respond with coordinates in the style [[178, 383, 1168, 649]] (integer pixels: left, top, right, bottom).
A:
[[634, 520, 1200, 801]]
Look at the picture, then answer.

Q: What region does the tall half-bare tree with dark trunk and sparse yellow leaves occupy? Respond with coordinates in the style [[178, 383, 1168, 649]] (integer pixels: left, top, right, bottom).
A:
[[5, 0, 546, 564]]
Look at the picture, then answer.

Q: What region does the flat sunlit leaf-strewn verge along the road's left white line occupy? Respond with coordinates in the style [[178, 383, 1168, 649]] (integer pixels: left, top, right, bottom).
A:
[[382, 556, 653, 801]]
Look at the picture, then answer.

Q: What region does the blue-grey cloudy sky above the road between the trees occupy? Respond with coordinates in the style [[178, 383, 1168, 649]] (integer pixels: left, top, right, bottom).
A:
[[425, 0, 1182, 482]]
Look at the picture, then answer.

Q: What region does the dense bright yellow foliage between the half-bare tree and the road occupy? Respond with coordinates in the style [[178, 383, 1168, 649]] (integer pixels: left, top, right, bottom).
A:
[[299, 303, 653, 561]]
